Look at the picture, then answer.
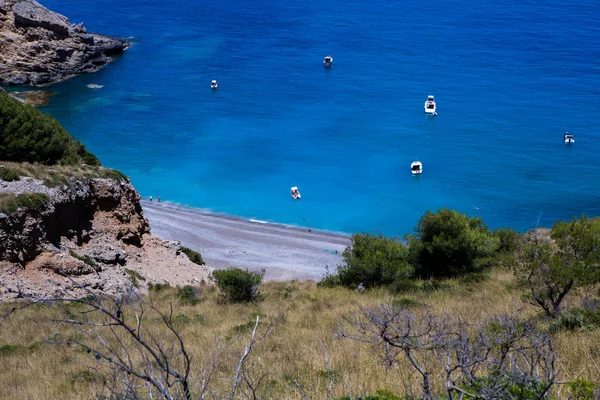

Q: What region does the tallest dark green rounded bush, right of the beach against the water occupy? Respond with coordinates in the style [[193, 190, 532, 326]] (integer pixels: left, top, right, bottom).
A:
[[407, 208, 500, 278]]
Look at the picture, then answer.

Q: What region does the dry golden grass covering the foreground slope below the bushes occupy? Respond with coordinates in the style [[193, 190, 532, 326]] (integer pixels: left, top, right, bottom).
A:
[[0, 276, 600, 400]]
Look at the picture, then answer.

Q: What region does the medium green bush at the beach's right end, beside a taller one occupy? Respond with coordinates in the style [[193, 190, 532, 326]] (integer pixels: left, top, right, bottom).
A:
[[330, 233, 413, 288]]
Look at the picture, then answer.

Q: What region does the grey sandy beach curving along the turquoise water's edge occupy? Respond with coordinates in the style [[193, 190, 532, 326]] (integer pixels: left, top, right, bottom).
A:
[[141, 200, 350, 281]]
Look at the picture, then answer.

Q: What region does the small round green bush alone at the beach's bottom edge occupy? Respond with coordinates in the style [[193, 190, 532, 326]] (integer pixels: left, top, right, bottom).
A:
[[211, 268, 265, 303]]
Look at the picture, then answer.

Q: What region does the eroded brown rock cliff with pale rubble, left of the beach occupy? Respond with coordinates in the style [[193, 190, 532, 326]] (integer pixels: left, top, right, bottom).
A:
[[0, 176, 210, 300]]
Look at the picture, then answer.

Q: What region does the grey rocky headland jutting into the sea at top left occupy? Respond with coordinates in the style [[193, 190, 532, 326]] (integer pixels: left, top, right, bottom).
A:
[[0, 0, 129, 86]]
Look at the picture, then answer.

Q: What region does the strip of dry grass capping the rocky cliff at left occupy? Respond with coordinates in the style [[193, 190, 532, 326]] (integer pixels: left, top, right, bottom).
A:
[[0, 161, 126, 187]]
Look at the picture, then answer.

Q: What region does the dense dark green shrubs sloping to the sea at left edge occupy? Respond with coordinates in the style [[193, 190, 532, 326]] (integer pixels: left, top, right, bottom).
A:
[[0, 92, 100, 166]]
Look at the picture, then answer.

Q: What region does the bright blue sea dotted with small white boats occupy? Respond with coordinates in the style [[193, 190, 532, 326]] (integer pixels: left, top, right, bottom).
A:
[[35, 0, 600, 237]]
